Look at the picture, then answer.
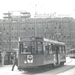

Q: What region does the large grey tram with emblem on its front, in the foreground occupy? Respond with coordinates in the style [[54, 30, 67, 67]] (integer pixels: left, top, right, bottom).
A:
[[18, 37, 66, 70]]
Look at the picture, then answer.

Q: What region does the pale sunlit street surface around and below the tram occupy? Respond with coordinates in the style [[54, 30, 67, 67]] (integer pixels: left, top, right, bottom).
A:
[[0, 57, 75, 75]]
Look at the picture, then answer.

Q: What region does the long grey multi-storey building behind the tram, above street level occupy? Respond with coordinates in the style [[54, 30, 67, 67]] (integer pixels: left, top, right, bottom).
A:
[[0, 12, 75, 52]]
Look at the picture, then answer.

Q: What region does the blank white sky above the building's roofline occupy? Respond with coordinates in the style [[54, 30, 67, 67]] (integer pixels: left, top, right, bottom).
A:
[[0, 0, 75, 18]]
